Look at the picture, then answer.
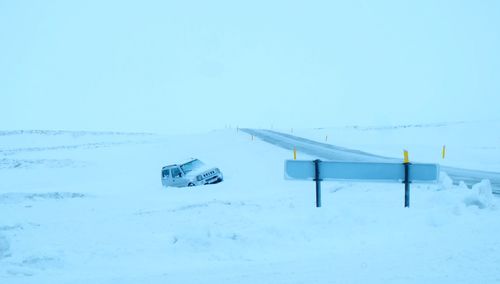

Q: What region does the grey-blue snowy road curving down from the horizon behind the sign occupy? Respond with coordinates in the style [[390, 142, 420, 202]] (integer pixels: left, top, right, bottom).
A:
[[242, 129, 500, 194]]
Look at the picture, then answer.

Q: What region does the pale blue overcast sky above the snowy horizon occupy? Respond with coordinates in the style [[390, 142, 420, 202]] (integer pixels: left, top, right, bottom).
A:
[[0, 0, 500, 132]]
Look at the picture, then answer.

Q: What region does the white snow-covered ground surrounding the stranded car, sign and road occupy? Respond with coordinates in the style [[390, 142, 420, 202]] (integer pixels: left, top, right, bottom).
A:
[[0, 127, 500, 283]]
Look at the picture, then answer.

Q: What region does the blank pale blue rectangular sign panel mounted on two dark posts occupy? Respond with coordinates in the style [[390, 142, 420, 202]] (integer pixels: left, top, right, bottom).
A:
[[285, 160, 439, 183]]
